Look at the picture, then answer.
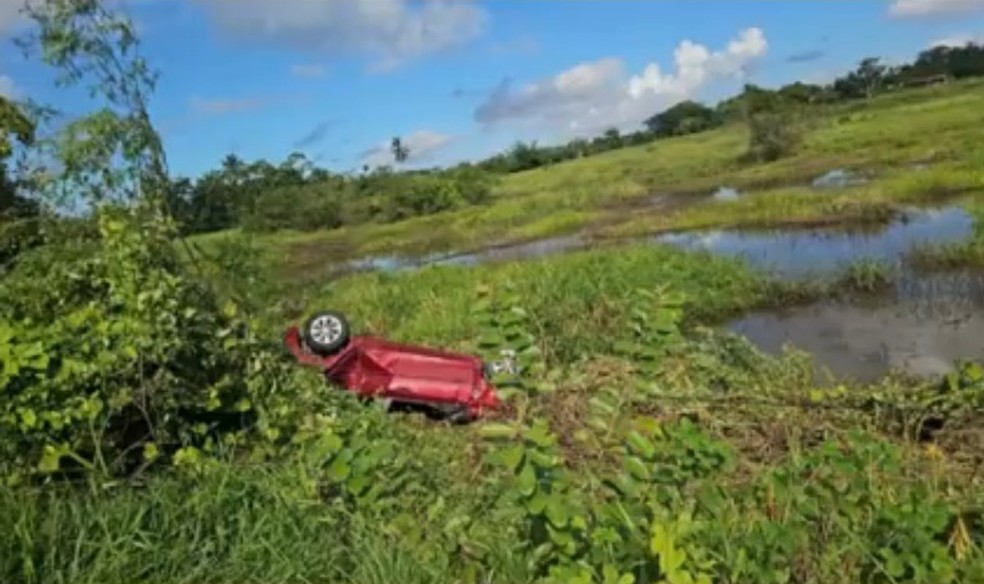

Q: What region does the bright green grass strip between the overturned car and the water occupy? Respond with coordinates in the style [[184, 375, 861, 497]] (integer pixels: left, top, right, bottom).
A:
[[306, 244, 797, 362]]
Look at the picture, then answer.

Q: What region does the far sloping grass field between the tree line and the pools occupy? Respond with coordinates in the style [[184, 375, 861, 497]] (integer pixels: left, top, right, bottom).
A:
[[190, 81, 984, 286]]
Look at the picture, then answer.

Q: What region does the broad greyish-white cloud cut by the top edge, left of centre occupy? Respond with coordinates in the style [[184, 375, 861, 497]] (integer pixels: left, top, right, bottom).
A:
[[192, 0, 488, 69]]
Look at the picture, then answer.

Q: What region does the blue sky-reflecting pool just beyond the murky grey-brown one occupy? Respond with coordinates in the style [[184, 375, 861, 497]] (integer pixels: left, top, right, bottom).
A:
[[651, 207, 974, 278]]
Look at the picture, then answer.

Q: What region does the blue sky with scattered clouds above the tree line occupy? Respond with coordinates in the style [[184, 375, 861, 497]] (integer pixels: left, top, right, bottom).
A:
[[0, 0, 984, 176]]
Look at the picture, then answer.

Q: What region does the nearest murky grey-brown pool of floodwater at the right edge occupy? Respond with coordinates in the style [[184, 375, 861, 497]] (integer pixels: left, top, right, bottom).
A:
[[726, 271, 984, 382]]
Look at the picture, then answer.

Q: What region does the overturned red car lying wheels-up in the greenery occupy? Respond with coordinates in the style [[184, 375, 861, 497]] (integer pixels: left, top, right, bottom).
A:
[[284, 311, 504, 422]]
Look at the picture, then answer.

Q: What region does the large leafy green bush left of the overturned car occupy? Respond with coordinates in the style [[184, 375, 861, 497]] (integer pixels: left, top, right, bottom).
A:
[[0, 210, 318, 482]]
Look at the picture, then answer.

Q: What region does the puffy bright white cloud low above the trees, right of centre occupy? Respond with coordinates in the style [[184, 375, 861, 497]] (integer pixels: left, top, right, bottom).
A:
[[475, 28, 769, 134]]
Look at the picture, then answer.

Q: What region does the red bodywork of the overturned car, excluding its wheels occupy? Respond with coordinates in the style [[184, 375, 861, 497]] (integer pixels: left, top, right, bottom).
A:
[[284, 326, 501, 419]]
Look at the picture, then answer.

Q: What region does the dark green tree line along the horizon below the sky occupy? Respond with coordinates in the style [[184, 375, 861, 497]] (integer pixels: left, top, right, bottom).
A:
[[0, 43, 984, 240]]
